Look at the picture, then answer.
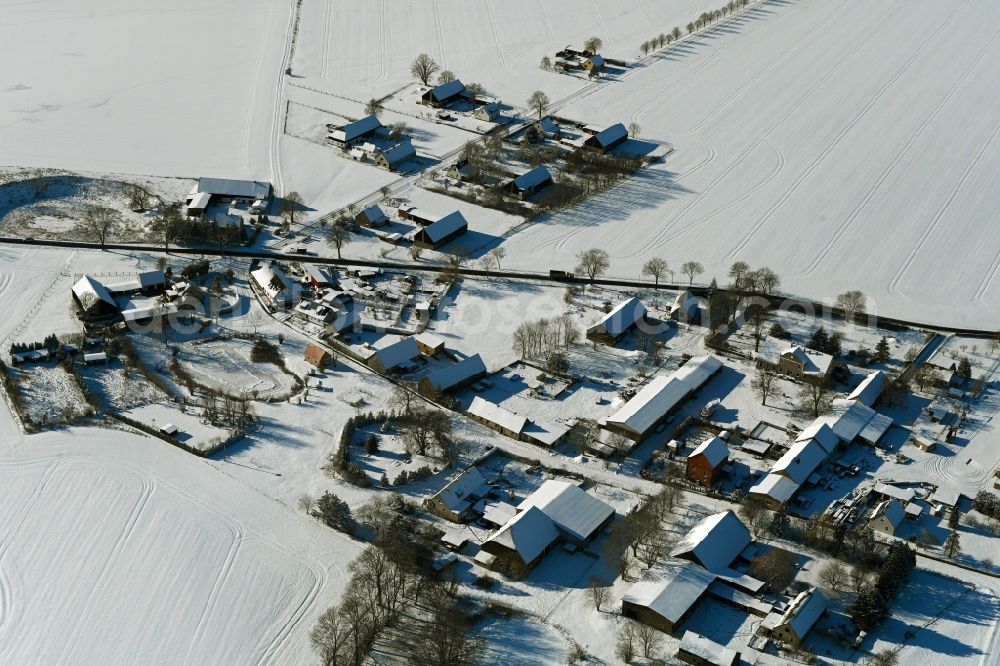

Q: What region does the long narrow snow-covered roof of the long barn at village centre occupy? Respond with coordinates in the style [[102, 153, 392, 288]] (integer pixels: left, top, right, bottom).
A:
[[607, 355, 722, 435]]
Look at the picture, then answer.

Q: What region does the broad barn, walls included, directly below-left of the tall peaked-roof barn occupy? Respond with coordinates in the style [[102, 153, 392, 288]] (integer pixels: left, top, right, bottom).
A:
[[622, 558, 715, 634]]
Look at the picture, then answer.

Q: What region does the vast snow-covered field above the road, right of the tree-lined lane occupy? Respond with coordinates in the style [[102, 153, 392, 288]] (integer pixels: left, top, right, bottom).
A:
[[500, 0, 1000, 326]]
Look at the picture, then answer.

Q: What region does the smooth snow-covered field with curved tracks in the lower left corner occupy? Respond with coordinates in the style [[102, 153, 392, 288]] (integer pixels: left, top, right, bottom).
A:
[[0, 426, 358, 664]]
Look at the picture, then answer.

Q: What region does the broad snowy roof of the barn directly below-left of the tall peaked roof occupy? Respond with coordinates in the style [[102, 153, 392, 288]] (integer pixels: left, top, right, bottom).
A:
[[622, 559, 715, 623]]
